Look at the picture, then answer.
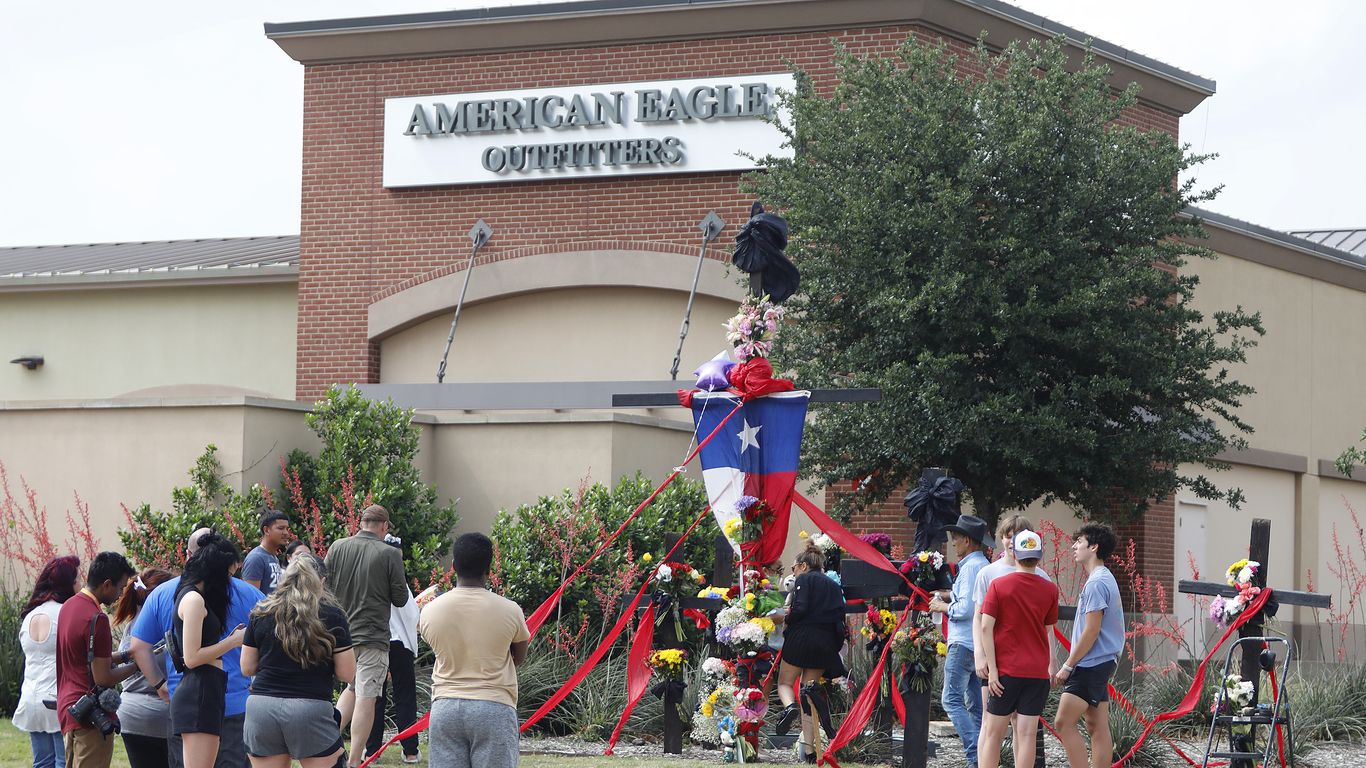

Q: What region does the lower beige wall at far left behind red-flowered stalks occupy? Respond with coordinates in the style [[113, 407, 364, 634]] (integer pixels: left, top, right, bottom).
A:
[[0, 398, 317, 579]]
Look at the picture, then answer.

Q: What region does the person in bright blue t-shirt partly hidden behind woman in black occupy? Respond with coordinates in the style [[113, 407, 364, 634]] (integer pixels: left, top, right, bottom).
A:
[[128, 529, 265, 768]]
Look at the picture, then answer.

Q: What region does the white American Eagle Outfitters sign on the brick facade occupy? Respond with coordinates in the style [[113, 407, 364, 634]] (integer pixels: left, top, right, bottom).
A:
[[384, 74, 794, 187]]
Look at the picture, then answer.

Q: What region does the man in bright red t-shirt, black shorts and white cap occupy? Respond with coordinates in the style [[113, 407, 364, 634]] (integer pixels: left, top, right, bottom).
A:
[[977, 530, 1057, 768]]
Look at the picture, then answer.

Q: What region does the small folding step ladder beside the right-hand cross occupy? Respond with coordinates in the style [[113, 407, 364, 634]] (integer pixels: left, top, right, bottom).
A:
[[1201, 637, 1295, 768]]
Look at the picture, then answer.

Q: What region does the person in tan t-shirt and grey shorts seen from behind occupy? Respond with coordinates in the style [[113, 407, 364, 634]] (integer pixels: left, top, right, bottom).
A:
[[418, 533, 531, 768]]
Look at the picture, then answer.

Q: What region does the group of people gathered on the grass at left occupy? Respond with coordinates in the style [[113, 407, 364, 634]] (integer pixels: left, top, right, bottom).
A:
[[14, 504, 529, 768]]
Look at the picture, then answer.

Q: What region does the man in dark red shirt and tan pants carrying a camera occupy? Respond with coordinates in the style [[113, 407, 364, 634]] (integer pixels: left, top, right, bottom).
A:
[[57, 552, 138, 768]]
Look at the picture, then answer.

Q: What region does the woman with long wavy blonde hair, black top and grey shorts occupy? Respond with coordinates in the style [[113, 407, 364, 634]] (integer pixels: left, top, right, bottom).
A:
[[242, 558, 355, 768]]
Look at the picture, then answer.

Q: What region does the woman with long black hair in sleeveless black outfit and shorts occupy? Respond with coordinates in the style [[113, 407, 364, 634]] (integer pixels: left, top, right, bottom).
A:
[[171, 533, 246, 768]]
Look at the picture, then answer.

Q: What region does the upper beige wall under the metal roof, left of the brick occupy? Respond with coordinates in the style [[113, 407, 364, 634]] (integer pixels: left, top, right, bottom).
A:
[[0, 282, 298, 400]]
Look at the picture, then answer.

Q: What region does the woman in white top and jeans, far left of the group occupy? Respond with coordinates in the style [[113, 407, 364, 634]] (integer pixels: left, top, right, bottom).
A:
[[14, 555, 81, 768]]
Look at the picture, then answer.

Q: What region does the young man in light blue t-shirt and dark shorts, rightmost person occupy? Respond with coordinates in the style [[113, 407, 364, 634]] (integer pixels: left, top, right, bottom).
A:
[[1053, 523, 1124, 768]]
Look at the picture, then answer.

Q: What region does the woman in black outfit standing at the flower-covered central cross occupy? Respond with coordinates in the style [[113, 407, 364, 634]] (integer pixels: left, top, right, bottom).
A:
[[779, 544, 844, 763]]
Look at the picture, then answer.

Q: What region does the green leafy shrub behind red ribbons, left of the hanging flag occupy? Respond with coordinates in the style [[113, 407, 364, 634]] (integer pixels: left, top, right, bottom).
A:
[[493, 473, 716, 628]]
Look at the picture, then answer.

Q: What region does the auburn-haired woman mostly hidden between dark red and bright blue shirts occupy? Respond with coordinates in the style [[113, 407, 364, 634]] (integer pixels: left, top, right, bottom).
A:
[[113, 568, 175, 768]]
